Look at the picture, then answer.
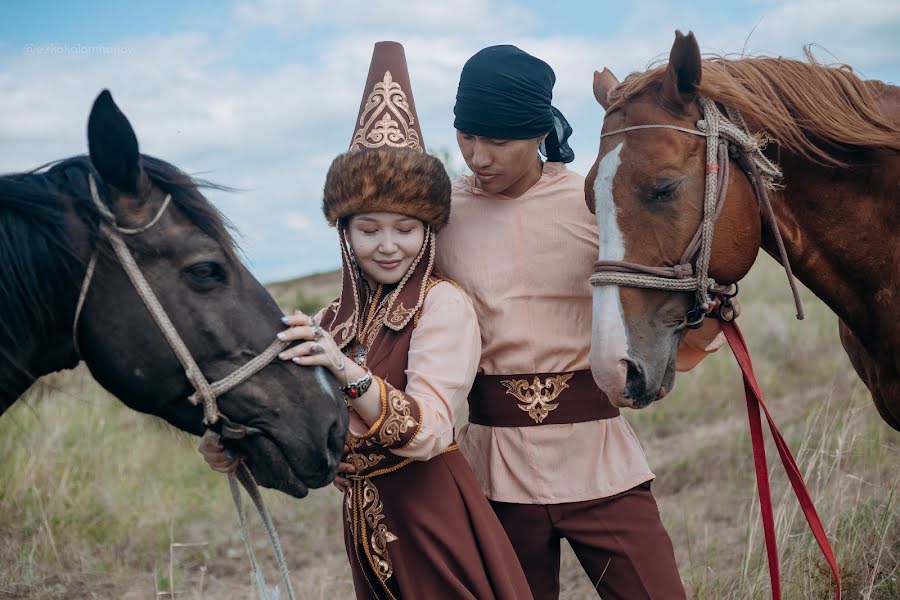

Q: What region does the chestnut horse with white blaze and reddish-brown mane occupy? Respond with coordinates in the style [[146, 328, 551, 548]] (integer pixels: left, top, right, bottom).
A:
[[585, 32, 900, 429]]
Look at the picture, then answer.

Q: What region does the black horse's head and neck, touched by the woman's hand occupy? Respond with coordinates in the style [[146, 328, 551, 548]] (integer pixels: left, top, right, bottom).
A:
[[0, 91, 347, 497]]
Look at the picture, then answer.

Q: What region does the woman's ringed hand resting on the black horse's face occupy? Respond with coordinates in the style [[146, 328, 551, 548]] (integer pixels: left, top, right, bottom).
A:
[[278, 311, 366, 383]]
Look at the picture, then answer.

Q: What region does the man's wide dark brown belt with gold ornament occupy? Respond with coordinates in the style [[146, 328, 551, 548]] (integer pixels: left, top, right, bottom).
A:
[[469, 370, 619, 427]]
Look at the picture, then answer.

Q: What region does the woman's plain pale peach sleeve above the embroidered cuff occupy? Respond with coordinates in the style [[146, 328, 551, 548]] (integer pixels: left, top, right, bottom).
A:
[[328, 281, 481, 460]]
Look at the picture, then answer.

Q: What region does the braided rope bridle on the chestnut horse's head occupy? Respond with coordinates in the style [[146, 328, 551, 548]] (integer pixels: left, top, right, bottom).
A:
[[590, 97, 803, 327]]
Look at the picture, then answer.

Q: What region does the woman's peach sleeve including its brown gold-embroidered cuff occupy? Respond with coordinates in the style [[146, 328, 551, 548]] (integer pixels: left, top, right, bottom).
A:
[[348, 282, 481, 460]]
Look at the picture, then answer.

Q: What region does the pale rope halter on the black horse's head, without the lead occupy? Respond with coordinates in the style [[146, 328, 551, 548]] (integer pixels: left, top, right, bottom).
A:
[[72, 174, 287, 439]]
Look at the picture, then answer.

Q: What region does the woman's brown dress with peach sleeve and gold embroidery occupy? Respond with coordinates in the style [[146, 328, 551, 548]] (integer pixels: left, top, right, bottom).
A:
[[321, 234, 531, 600]]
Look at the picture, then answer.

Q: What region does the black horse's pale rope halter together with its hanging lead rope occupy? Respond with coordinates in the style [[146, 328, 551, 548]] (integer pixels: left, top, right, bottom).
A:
[[79, 174, 295, 600]]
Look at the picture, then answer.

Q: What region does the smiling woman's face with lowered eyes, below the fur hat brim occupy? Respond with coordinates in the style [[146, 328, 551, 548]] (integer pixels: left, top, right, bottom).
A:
[[347, 212, 425, 285]]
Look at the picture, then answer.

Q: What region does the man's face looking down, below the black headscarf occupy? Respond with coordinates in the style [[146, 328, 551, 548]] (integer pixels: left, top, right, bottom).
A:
[[456, 130, 546, 198]]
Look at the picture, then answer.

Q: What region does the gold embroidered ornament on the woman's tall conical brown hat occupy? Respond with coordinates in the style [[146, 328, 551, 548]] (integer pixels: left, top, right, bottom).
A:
[[349, 71, 424, 152]]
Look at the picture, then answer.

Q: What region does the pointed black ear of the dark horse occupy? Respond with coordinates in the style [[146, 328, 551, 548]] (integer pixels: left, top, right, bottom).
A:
[[88, 90, 141, 194]]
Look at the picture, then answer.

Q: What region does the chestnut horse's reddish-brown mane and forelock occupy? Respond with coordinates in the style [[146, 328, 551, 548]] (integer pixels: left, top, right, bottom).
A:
[[610, 50, 900, 167]]
